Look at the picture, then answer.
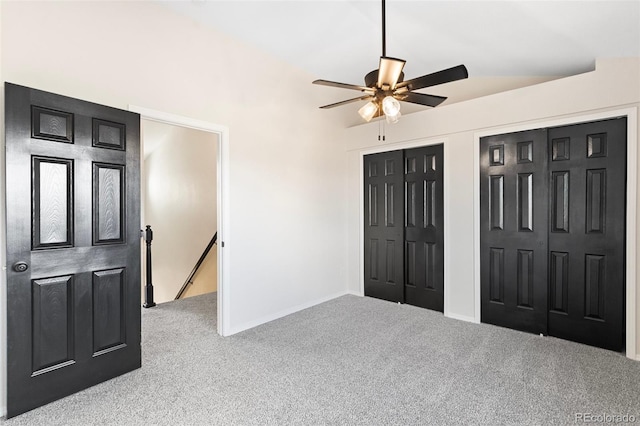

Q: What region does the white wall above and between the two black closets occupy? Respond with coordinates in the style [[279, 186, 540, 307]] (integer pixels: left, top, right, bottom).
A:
[[345, 58, 640, 356]]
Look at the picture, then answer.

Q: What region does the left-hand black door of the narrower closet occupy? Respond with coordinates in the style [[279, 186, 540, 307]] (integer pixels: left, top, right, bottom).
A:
[[364, 151, 404, 302]]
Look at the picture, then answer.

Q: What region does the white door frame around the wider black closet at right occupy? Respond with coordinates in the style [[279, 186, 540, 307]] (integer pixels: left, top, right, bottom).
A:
[[472, 107, 640, 361]]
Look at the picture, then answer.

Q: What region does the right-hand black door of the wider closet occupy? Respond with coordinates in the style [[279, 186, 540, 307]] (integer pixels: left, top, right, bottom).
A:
[[549, 118, 627, 351]]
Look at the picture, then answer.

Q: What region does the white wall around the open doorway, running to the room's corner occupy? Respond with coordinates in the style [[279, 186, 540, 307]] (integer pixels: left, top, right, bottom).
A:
[[0, 2, 346, 412]]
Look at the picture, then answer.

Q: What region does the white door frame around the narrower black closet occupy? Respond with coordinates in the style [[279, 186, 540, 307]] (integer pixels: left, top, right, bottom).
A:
[[357, 137, 457, 318]]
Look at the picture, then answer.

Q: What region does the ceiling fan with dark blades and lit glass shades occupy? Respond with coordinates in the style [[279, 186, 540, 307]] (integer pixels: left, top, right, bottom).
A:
[[313, 0, 469, 123]]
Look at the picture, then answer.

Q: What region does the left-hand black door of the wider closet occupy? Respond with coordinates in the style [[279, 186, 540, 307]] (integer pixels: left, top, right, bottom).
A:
[[480, 130, 548, 334]]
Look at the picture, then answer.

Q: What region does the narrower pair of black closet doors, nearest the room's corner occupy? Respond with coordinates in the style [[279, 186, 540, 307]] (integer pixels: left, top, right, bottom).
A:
[[364, 145, 444, 312]]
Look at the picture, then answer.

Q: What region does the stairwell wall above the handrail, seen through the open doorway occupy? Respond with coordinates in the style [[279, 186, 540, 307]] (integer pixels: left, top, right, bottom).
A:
[[142, 120, 218, 303]]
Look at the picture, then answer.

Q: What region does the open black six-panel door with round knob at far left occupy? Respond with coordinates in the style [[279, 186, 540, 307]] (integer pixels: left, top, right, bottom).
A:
[[5, 83, 140, 417]]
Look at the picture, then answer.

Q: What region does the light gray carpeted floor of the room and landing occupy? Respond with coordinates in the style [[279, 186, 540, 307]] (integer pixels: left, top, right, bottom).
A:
[[0, 294, 640, 426]]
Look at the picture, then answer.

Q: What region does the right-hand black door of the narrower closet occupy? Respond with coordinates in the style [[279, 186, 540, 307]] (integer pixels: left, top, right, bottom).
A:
[[404, 145, 444, 312]]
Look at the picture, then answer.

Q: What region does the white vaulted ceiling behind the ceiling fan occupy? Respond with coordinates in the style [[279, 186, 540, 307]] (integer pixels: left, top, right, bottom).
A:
[[160, 0, 640, 124]]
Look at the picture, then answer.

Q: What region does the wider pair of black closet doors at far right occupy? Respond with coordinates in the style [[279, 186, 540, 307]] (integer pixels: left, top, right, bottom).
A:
[[480, 118, 627, 351]]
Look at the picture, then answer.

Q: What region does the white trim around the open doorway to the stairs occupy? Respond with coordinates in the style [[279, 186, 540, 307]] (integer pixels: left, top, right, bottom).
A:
[[129, 105, 233, 336]]
